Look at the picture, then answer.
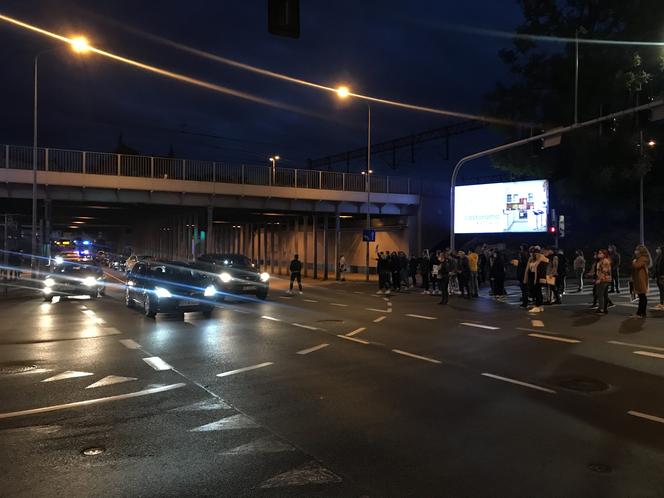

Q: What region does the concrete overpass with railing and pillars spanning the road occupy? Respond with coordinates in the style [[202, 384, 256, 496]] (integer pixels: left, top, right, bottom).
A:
[[0, 145, 430, 276]]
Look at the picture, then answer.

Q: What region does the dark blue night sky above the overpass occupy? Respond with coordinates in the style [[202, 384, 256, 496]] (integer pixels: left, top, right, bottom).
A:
[[0, 0, 521, 176]]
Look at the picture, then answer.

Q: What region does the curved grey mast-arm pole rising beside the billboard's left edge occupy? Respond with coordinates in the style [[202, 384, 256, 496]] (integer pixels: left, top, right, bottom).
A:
[[450, 100, 664, 251]]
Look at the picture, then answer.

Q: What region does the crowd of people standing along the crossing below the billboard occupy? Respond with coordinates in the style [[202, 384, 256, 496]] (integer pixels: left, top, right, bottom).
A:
[[370, 245, 664, 318]]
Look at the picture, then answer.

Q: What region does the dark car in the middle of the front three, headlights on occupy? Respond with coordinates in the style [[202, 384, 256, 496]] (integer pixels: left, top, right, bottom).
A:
[[125, 260, 217, 318]]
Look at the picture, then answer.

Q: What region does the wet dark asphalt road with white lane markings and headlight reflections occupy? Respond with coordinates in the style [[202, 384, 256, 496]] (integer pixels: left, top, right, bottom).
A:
[[0, 274, 664, 497]]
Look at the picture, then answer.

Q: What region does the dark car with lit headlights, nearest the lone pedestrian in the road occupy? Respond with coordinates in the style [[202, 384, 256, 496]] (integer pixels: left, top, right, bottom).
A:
[[196, 254, 270, 300]]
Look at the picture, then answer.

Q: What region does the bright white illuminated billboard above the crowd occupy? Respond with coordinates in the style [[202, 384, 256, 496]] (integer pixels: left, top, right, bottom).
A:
[[454, 180, 549, 233]]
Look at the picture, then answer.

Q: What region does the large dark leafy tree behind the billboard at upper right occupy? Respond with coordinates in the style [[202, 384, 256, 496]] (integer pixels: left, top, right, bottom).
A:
[[487, 0, 664, 244]]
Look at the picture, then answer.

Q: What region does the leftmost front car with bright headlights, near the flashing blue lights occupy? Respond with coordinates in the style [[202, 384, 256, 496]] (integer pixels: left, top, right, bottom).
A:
[[42, 253, 106, 301]]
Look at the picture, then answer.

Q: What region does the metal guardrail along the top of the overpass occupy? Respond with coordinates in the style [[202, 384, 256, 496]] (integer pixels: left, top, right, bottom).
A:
[[0, 145, 422, 194]]
